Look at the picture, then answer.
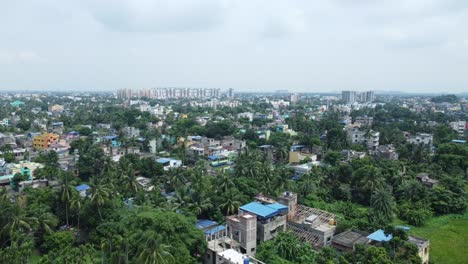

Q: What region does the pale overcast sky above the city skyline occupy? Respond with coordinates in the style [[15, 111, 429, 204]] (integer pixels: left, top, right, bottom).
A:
[[0, 0, 468, 93]]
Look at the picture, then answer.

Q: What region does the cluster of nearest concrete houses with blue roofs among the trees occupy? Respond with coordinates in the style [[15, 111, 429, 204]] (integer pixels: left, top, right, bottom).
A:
[[195, 192, 430, 264]]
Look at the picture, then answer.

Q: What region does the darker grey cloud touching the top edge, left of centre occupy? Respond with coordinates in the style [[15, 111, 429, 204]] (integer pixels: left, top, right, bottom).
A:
[[87, 0, 229, 32]]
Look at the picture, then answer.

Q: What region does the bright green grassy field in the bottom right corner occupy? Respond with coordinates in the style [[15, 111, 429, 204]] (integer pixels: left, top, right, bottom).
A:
[[400, 213, 468, 264]]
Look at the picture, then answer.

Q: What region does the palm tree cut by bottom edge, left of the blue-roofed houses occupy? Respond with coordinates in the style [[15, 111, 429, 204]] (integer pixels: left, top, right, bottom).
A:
[[138, 230, 174, 264]]
